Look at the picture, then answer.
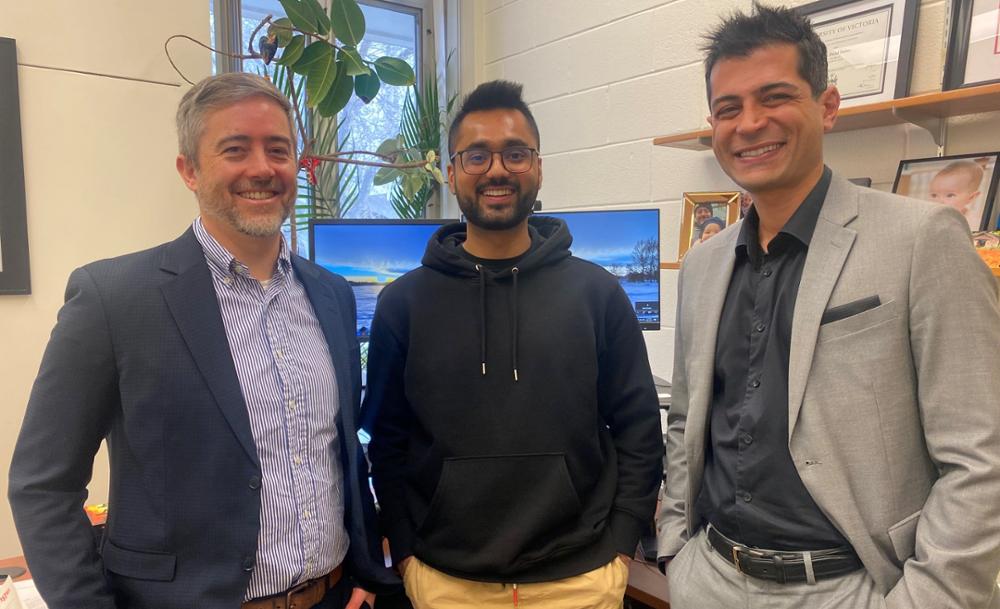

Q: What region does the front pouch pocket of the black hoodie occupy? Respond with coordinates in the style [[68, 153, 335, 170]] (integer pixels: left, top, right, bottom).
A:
[[417, 453, 581, 575]]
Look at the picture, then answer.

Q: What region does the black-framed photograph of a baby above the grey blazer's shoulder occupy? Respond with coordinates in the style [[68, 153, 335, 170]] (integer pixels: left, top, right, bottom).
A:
[[892, 152, 1000, 231]]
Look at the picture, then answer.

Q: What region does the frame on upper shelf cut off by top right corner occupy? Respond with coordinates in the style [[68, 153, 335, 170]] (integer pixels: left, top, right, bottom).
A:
[[944, 0, 1000, 91]]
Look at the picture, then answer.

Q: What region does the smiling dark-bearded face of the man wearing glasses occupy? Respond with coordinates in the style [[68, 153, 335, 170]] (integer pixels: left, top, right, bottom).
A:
[[448, 109, 542, 230]]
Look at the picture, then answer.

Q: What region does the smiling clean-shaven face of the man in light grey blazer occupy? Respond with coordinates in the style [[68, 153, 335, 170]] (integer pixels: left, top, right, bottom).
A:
[[708, 43, 840, 201]]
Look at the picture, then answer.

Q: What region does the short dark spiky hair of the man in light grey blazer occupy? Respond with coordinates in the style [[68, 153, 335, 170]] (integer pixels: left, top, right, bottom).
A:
[[701, 1, 829, 104]]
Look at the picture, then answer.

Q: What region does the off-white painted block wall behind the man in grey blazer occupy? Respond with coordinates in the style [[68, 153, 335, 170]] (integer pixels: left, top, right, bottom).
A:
[[460, 0, 1000, 378]]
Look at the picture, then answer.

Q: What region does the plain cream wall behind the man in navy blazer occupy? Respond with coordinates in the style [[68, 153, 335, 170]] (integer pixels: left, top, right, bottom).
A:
[[0, 0, 210, 557]]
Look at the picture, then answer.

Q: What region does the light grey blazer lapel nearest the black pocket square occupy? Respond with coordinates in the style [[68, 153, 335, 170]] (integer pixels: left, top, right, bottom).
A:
[[788, 175, 858, 441]]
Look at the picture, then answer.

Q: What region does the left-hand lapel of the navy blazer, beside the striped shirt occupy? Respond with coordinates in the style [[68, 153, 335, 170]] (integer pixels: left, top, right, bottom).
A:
[[160, 229, 260, 467]]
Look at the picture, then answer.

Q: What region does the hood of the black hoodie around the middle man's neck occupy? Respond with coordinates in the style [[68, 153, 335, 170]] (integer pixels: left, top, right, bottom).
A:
[[421, 216, 573, 277]]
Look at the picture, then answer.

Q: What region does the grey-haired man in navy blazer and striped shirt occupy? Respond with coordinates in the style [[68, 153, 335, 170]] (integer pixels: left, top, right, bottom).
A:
[[10, 74, 398, 609]]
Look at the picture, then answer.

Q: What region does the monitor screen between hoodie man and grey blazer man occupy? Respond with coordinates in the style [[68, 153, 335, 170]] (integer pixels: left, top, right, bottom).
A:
[[541, 209, 660, 330]]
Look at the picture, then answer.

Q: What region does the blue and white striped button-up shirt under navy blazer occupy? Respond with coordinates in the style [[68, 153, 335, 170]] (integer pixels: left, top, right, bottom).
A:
[[193, 218, 350, 600]]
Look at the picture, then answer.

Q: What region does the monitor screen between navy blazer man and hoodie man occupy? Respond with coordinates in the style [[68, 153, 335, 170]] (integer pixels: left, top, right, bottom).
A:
[[309, 220, 444, 341]]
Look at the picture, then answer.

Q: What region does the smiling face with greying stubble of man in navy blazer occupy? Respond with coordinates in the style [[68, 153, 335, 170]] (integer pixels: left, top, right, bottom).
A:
[[177, 97, 298, 245]]
